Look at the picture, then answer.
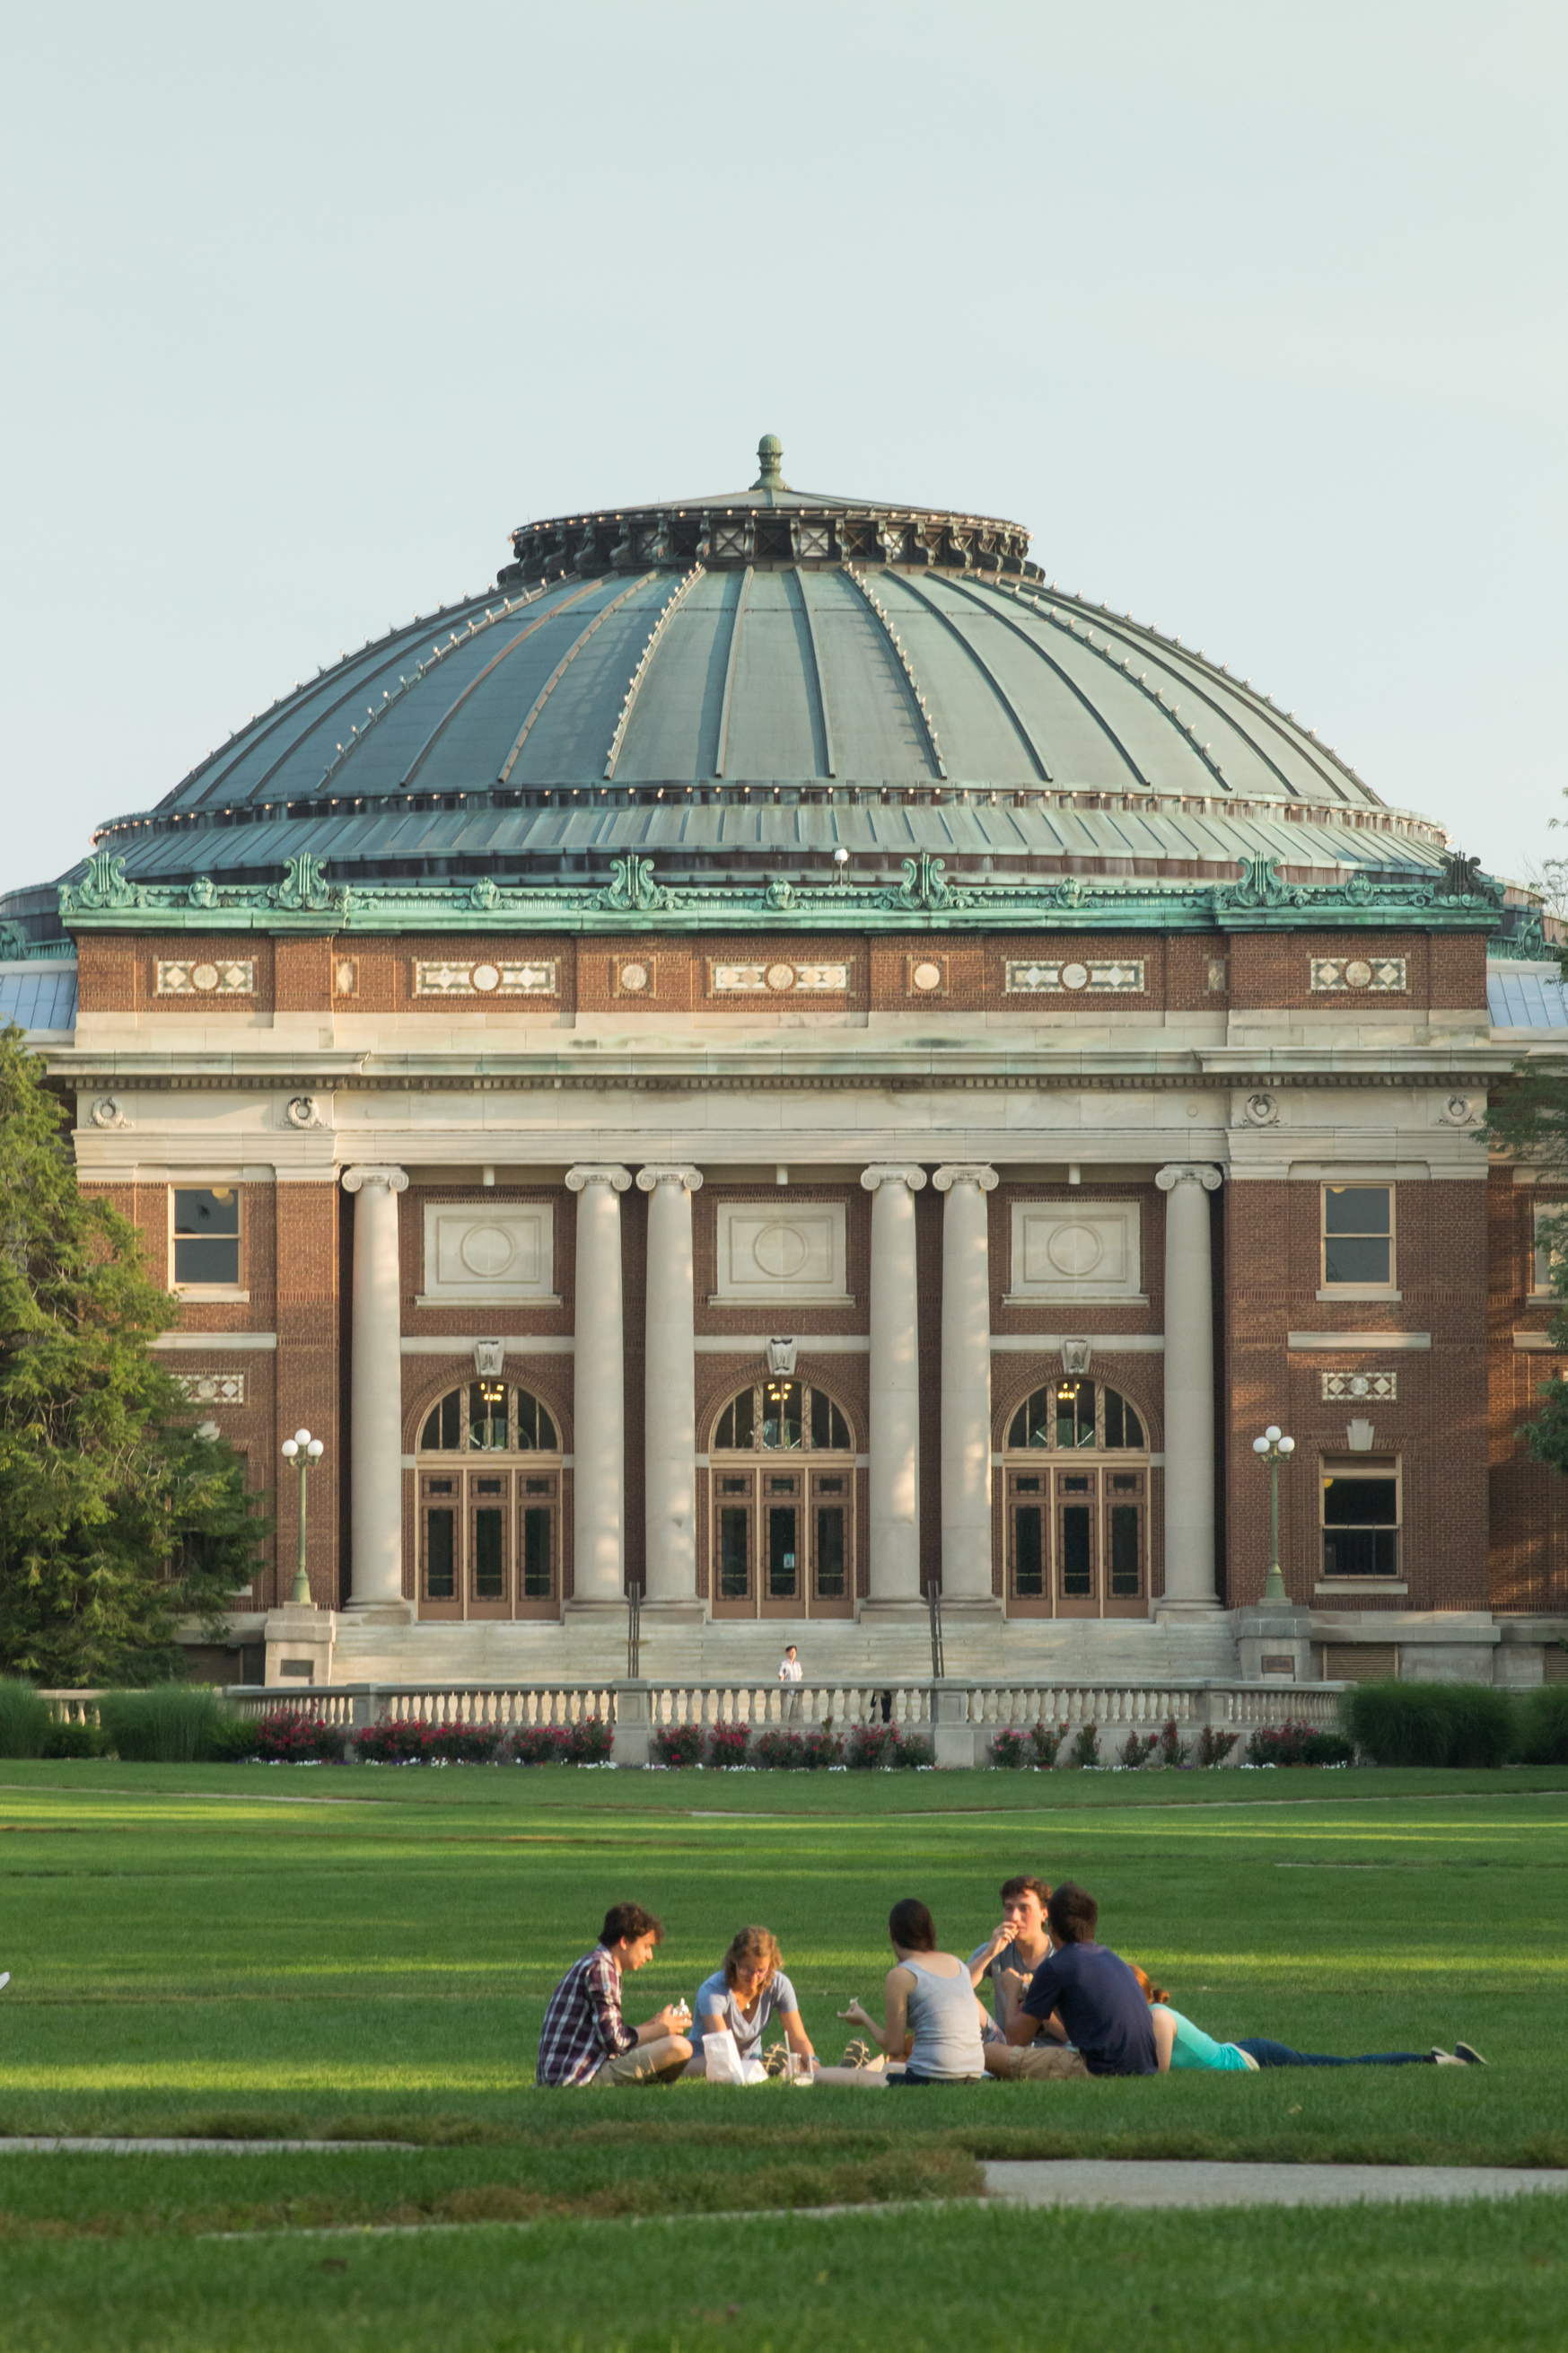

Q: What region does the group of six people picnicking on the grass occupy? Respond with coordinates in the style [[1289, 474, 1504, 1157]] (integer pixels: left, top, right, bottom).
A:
[[539, 1873, 1485, 2089]]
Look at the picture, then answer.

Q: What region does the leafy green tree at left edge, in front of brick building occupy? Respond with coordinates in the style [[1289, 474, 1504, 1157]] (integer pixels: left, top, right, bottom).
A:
[[0, 1028, 268, 1685]]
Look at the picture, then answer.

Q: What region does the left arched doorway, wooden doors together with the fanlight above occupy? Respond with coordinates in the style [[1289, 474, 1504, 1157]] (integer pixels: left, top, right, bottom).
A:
[[416, 1379, 562, 1619]]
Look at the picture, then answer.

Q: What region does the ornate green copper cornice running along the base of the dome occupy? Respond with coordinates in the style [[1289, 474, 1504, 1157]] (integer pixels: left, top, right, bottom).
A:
[[58, 852, 1502, 935]]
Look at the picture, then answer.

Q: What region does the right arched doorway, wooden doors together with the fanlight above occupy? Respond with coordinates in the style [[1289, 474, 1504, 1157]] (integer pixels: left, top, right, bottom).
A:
[[1003, 1374, 1150, 1617]]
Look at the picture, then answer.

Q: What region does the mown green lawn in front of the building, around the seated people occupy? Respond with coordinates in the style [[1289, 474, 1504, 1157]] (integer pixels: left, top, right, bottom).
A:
[[0, 1762, 1568, 2353]]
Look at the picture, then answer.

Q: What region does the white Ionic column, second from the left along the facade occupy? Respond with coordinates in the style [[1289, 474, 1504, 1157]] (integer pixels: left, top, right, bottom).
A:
[[566, 1167, 633, 1602]]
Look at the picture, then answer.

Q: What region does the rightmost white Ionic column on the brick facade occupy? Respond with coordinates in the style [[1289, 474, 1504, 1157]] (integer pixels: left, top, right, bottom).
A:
[[1154, 1160, 1220, 1610]]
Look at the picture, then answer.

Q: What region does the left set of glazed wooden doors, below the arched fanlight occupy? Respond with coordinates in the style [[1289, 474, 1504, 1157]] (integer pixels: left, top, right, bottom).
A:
[[418, 1462, 562, 1619]]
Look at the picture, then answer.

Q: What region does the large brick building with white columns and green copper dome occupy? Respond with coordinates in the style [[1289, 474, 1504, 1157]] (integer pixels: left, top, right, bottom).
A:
[[0, 435, 1568, 1713]]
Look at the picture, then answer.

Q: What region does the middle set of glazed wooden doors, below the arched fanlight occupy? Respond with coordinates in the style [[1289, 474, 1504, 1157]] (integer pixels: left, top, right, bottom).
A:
[[710, 1459, 855, 1617]]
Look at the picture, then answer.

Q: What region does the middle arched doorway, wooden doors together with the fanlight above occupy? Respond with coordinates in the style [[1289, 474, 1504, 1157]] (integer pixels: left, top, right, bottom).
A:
[[707, 1374, 855, 1619]]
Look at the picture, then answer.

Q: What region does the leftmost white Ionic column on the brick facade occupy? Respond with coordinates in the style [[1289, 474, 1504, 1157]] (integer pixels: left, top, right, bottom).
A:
[[343, 1167, 409, 1610]]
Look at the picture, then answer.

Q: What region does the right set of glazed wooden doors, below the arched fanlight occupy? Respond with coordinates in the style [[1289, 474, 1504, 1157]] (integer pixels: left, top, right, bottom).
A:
[[1006, 1454, 1150, 1617]]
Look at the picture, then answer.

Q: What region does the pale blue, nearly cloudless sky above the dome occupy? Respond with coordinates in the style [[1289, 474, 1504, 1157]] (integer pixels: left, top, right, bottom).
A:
[[0, 0, 1568, 887]]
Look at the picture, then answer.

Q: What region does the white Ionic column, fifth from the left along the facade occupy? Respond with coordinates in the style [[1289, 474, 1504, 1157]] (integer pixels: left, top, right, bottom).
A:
[[931, 1164, 997, 1602]]
